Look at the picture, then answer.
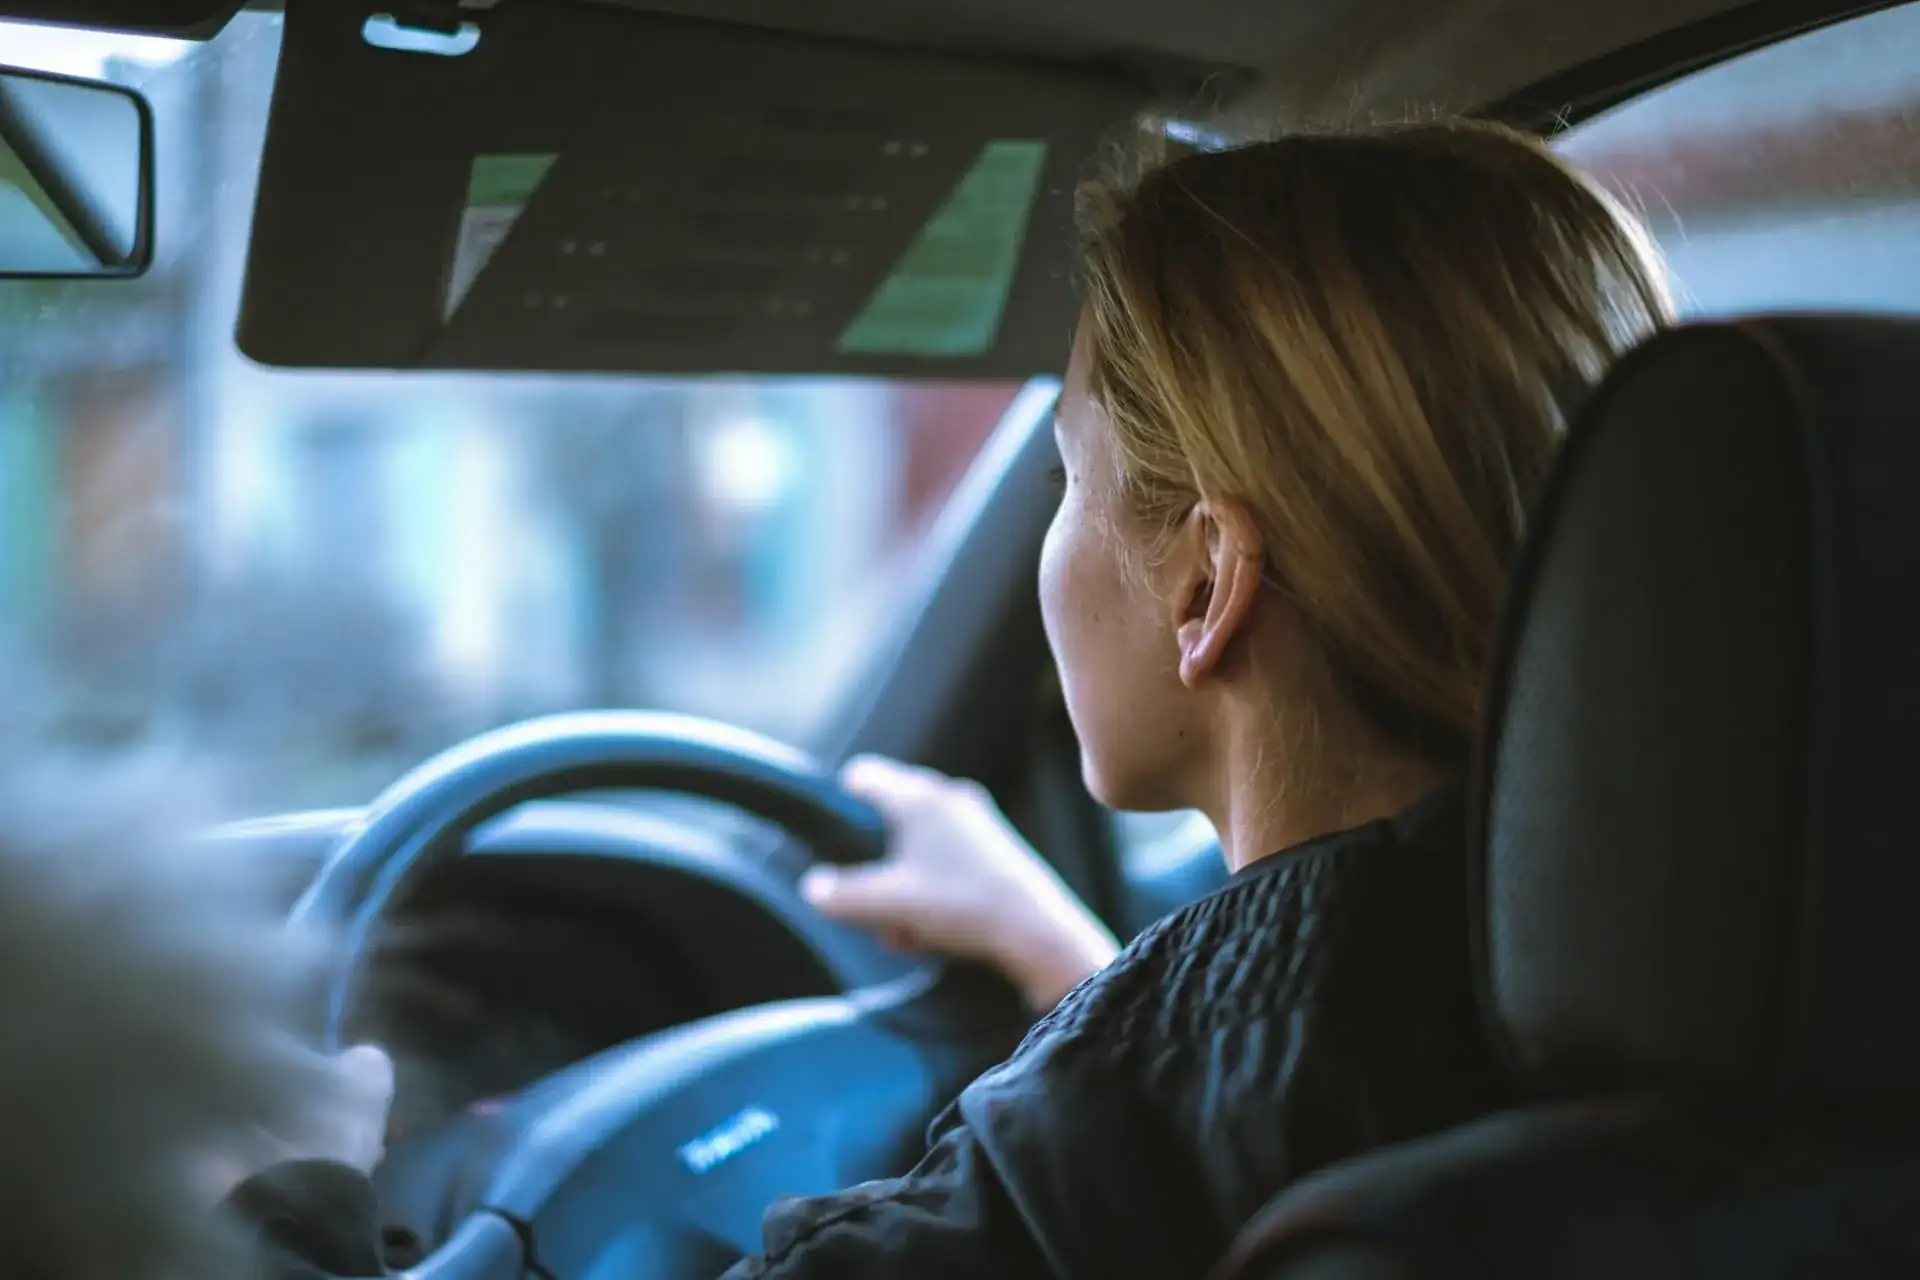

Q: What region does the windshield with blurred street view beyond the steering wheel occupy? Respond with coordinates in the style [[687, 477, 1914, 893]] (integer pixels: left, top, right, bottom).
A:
[[0, 13, 1020, 810]]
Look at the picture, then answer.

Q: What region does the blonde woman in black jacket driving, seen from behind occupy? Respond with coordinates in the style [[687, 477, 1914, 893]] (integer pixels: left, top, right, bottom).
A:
[[228, 123, 1667, 1280]]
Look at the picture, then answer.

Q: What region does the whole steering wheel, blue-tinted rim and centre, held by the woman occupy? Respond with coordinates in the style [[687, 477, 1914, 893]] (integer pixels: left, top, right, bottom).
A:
[[292, 712, 1029, 1280]]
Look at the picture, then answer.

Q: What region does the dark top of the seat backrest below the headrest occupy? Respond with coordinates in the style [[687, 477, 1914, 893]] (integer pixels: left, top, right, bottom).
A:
[[1223, 1102, 1920, 1280]]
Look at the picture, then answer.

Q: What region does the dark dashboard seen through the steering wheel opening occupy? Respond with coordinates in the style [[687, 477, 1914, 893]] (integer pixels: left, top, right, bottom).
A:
[[209, 794, 910, 1136]]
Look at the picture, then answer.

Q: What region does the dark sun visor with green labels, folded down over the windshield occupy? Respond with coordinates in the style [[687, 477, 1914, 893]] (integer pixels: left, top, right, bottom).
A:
[[238, 0, 1144, 378]]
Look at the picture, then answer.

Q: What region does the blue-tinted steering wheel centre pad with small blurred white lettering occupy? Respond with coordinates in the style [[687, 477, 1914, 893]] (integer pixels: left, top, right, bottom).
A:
[[484, 998, 941, 1274]]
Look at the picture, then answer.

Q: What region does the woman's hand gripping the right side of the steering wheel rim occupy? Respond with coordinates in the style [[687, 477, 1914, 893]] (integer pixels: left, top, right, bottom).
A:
[[801, 756, 1119, 1011]]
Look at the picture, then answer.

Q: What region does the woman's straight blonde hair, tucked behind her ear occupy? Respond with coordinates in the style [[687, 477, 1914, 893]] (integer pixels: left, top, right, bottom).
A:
[[1081, 121, 1668, 764]]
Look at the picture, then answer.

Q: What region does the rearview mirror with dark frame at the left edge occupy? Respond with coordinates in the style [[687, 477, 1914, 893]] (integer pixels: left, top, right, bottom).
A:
[[0, 67, 154, 280]]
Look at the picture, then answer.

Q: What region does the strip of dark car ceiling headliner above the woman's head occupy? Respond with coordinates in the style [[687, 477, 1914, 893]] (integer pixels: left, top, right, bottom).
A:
[[612, 0, 1740, 123]]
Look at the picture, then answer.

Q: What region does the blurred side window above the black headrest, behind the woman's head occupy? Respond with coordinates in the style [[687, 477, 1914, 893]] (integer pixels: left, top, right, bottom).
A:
[[1555, 4, 1920, 317]]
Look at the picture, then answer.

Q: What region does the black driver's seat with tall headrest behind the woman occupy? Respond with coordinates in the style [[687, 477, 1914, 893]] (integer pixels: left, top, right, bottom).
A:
[[1221, 319, 1920, 1280]]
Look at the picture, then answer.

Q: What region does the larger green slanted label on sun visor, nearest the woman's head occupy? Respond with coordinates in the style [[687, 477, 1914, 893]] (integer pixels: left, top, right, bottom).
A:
[[839, 138, 1046, 359]]
